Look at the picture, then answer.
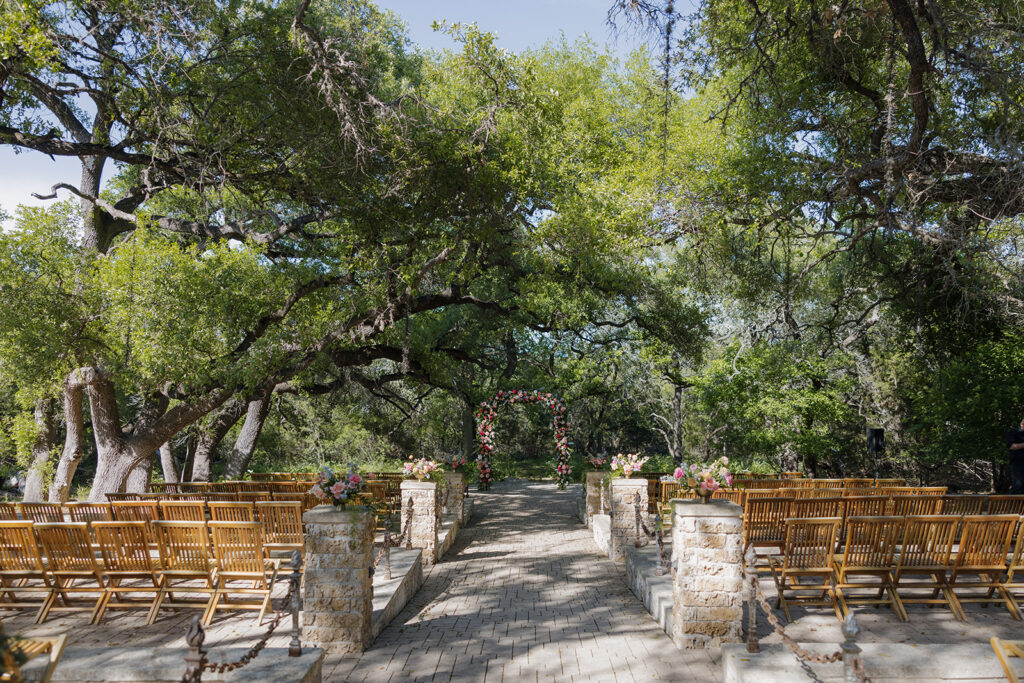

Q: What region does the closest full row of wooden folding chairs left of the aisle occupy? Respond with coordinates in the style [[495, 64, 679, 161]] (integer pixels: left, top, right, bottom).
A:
[[0, 520, 280, 625]]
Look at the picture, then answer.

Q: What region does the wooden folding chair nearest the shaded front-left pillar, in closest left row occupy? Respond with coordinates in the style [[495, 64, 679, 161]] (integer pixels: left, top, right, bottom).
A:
[[206, 522, 281, 626]]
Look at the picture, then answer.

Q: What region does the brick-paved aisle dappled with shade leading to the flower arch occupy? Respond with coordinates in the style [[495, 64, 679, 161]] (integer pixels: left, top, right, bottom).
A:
[[324, 482, 720, 683]]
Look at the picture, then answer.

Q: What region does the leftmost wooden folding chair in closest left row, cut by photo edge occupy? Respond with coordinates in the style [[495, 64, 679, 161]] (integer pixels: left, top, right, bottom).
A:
[[0, 520, 52, 623]]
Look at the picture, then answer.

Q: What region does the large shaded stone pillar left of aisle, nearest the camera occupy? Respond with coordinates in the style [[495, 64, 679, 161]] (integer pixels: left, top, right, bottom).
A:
[[302, 505, 376, 652]]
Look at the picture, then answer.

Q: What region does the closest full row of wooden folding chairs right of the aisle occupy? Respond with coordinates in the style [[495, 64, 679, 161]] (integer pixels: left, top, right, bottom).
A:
[[769, 515, 1024, 621]]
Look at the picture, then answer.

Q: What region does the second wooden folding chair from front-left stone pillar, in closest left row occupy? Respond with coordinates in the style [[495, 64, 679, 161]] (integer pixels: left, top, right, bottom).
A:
[[145, 520, 215, 624]]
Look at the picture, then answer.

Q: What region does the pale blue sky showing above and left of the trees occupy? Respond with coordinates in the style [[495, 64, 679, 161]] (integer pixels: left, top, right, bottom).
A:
[[0, 0, 638, 218]]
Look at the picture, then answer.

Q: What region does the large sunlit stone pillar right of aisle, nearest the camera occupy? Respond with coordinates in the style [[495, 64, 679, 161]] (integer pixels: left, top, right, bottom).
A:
[[672, 499, 746, 649]]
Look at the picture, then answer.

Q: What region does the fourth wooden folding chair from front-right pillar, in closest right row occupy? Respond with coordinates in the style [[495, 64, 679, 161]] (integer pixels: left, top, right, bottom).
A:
[[949, 515, 1021, 622]]
